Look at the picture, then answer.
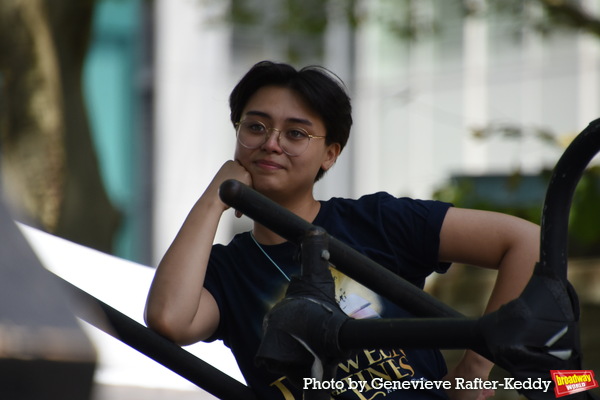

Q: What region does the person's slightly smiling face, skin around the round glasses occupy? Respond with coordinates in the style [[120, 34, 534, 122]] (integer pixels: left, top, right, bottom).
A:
[[235, 86, 340, 200]]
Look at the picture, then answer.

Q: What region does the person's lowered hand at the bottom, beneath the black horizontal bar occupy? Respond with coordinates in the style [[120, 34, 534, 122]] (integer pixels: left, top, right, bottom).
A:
[[444, 350, 495, 400]]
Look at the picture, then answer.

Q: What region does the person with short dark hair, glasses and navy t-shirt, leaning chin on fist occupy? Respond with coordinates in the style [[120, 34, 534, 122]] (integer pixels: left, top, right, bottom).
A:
[[145, 61, 539, 400]]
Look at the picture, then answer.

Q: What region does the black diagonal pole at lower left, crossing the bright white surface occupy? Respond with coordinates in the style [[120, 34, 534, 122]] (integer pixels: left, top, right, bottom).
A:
[[54, 275, 256, 400]]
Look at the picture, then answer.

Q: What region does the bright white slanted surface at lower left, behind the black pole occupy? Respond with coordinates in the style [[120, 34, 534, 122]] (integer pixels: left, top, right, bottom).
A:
[[19, 225, 244, 390]]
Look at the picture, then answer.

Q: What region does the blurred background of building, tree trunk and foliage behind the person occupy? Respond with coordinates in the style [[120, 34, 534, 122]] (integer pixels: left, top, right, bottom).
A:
[[0, 0, 600, 398]]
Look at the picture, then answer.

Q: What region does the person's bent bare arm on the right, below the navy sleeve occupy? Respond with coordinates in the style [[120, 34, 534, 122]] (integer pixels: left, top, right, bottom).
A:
[[440, 208, 540, 399]]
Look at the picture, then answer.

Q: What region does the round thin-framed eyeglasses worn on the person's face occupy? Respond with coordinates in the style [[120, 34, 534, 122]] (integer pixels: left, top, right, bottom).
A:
[[235, 119, 325, 157]]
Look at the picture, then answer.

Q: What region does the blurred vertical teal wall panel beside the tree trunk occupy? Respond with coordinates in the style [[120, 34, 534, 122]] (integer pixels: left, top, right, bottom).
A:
[[84, 0, 146, 261]]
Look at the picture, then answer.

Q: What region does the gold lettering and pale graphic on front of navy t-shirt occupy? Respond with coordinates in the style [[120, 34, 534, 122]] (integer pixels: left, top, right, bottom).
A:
[[270, 268, 420, 400]]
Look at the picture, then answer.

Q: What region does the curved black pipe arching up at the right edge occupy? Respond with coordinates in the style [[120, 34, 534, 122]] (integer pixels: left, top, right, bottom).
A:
[[539, 119, 600, 281]]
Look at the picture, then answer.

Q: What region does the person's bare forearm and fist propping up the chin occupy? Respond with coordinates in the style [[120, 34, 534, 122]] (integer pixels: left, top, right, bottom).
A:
[[145, 161, 251, 345]]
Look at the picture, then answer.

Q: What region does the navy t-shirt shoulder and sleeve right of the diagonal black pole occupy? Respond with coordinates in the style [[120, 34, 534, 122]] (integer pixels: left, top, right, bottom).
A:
[[322, 192, 452, 287]]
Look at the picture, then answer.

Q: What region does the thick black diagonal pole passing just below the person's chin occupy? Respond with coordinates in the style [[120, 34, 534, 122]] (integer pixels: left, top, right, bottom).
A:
[[219, 179, 463, 318]]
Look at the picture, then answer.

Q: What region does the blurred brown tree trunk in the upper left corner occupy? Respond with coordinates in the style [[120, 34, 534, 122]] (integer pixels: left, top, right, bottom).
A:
[[0, 0, 119, 252]]
